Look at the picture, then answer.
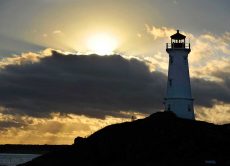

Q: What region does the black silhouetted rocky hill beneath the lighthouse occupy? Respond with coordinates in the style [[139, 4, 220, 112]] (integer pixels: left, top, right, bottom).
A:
[[18, 112, 230, 166]]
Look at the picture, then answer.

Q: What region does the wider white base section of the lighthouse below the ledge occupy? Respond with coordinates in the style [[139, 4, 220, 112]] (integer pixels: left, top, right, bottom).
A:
[[164, 98, 195, 120]]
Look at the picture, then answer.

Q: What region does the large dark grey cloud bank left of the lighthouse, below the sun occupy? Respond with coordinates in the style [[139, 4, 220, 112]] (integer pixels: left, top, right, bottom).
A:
[[0, 52, 166, 118]]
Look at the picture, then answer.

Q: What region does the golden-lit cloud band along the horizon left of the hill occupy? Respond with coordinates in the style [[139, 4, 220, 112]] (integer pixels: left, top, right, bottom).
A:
[[0, 114, 130, 144]]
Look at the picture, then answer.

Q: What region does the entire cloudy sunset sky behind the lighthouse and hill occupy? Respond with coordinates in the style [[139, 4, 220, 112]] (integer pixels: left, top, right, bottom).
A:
[[0, 0, 230, 144]]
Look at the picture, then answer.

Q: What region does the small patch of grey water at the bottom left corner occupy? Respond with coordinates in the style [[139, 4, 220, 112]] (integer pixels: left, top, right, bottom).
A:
[[0, 153, 40, 166]]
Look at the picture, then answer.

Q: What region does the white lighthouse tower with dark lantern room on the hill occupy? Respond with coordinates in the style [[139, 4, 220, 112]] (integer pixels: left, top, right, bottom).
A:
[[164, 30, 195, 119]]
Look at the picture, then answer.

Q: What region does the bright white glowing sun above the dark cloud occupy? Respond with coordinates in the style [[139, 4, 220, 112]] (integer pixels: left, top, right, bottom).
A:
[[87, 34, 117, 55]]
